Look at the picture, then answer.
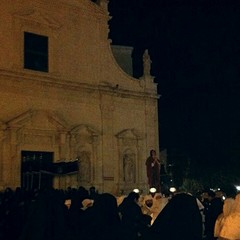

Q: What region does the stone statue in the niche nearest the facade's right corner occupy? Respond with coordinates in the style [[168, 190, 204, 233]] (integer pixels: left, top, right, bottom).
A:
[[123, 154, 135, 183]]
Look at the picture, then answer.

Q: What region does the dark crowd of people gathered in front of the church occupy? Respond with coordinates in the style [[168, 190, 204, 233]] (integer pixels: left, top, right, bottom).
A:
[[0, 187, 240, 240]]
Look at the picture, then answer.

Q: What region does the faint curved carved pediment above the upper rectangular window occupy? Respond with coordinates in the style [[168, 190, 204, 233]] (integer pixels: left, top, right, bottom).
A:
[[13, 9, 61, 29]]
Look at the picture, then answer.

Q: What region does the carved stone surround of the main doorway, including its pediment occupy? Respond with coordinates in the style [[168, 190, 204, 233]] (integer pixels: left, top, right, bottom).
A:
[[5, 110, 67, 185]]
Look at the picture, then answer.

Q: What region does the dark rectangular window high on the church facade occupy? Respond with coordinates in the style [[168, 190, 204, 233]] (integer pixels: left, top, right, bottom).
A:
[[24, 32, 48, 72]]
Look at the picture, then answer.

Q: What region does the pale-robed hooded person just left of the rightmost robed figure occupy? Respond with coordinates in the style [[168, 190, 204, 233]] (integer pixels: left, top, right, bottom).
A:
[[214, 198, 234, 240]]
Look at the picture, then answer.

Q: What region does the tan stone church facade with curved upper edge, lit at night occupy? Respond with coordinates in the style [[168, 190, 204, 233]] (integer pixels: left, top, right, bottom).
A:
[[0, 0, 159, 193]]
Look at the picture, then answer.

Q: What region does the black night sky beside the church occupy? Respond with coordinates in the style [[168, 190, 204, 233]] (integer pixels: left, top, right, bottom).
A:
[[109, 0, 240, 174]]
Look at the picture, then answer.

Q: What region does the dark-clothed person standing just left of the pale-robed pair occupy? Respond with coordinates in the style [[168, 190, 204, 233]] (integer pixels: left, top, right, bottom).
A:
[[204, 190, 223, 240]]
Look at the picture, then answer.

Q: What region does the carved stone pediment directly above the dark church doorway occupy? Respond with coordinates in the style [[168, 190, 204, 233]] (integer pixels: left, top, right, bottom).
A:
[[7, 110, 67, 131]]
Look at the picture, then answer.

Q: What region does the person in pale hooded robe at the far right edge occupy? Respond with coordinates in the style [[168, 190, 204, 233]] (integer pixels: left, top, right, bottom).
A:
[[219, 193, 240, 240]]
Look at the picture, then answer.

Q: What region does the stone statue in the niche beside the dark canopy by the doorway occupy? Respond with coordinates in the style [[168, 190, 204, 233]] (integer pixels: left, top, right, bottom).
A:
[[78, 151, 91, 182]]
